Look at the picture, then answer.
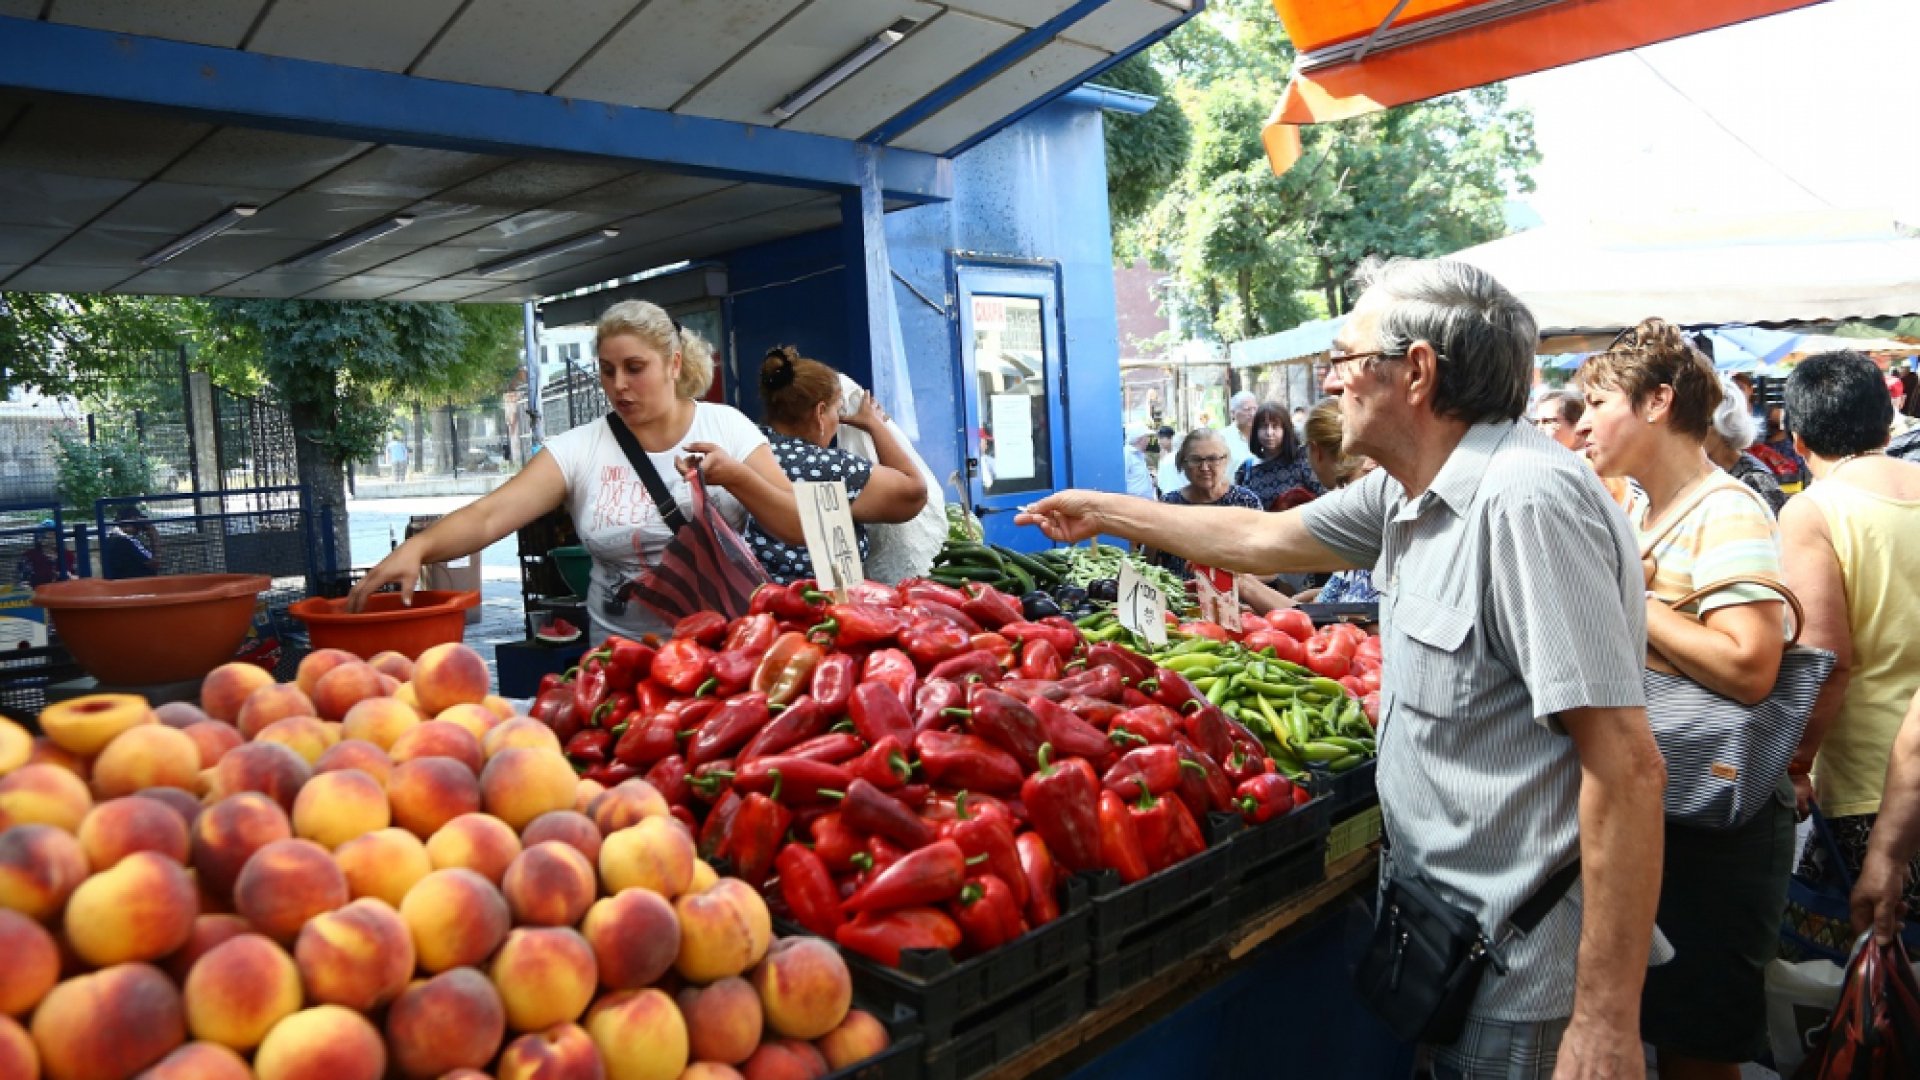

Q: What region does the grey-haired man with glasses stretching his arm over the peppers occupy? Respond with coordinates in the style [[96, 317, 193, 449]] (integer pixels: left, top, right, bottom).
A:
[[1020, 261, 1668, 1076]]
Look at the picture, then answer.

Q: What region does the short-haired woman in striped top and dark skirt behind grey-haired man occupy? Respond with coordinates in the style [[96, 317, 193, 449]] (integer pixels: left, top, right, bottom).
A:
[[1578, 319, 1793, 1080]]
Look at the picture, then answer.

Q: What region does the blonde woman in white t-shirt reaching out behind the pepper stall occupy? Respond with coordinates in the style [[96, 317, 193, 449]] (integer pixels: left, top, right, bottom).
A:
[[348, 300, 803, 642]]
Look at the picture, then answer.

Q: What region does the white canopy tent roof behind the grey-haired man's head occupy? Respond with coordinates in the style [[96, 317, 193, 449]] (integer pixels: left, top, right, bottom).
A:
[[1450, 211, 1920, 334]]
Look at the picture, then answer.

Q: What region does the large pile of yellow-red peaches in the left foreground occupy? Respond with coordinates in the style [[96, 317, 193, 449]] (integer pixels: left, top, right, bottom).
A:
[[0, 644, 887, 1080]]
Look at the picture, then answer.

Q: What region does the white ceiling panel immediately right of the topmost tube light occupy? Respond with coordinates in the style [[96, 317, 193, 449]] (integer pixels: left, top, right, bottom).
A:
[[781, 12, 1020, 138]]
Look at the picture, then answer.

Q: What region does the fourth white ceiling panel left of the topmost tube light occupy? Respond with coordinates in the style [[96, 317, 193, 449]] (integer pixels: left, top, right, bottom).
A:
[[248, 0, 464, 71]]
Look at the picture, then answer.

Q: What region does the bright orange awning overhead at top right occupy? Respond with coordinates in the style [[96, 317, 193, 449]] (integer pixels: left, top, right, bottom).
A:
[[1261, 0, 1820, 173]]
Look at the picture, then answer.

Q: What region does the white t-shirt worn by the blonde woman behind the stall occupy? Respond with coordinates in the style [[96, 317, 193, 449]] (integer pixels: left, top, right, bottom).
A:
[[545, 402, 766, 642]]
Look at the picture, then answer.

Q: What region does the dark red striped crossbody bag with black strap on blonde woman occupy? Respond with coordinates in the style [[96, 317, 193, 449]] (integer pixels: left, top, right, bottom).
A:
[[607, 415, 770, 623]]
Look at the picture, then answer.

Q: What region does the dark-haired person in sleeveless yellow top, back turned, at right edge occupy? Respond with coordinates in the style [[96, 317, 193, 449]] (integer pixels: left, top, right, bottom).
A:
[[1780, 352, 1920, 903]]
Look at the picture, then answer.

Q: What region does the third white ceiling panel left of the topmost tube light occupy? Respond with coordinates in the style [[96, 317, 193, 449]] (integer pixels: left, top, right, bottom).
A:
[[413, 0, 636, 94]]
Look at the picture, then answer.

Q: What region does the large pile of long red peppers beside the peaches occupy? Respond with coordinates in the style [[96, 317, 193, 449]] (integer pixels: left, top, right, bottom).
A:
[[532, 580, 1309, 965]]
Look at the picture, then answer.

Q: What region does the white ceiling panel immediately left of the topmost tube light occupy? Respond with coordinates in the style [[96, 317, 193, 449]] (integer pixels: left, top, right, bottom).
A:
[[674, 0, 939, 123]]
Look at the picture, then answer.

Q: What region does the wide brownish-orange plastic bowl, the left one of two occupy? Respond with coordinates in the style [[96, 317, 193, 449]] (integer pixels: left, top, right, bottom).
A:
[[33, 575, 273, 686]]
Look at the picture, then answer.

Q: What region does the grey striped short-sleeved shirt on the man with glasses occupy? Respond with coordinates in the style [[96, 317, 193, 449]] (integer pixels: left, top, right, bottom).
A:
[[1302, 423, 1665, 1022]]
